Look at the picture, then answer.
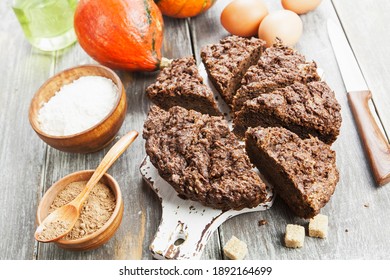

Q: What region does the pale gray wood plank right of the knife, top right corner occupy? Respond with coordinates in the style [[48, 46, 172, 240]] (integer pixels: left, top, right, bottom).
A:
[[332, 0, 390, 135]]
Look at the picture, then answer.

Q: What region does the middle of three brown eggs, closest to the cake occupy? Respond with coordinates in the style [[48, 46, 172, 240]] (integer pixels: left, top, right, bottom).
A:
[[259, 10, 303, 47]]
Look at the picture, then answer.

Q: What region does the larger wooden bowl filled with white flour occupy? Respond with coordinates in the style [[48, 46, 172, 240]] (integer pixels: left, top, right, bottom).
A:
[[29, 65, 127, 153]]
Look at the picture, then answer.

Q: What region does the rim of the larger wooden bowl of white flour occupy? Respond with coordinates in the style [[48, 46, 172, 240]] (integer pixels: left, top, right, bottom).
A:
[[28, 64, 125, 140]]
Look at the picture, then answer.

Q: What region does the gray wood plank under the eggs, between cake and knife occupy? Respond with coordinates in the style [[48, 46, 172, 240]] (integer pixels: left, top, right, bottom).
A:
[[191, 0, 390, 259]]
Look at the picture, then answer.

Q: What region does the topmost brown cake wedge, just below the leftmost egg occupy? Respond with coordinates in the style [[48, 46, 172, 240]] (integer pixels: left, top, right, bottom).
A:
[[200, 35, 265, 107]]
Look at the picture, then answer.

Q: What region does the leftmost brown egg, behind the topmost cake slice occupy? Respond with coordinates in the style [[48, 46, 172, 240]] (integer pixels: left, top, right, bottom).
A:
[[221, 0, 268, 37]]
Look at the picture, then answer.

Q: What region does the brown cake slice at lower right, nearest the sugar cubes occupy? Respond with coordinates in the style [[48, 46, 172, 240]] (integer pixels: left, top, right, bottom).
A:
[[245, 127, 339, 219]]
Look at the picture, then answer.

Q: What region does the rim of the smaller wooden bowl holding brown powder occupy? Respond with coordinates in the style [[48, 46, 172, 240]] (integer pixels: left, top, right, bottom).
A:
[[37, 169, 123, 246]]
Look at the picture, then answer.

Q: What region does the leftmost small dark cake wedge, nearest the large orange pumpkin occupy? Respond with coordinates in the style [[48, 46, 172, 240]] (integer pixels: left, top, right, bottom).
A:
[[146, 57, 221, 116]]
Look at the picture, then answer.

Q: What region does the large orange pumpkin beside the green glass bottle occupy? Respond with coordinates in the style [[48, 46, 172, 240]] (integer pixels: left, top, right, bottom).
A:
[[74, 0, 164, 71]]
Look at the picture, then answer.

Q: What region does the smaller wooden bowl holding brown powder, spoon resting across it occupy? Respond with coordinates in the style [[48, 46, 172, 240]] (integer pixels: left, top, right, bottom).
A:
[[37, 170, 123, 251]]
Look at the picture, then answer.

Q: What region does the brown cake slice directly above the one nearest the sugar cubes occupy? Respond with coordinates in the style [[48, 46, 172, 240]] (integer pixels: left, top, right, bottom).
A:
[[233, 81, 341, 144]]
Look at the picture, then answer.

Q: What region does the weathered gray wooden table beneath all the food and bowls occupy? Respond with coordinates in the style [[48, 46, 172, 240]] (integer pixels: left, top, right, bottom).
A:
[[0, 0, 390, 259]]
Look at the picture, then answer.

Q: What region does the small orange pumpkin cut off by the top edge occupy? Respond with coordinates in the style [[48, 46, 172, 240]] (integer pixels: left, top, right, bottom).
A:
[[155, 0, 216, 18]]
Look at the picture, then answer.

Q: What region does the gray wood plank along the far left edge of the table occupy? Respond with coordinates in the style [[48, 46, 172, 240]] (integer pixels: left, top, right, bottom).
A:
[[0, 1, 53, 259]]
